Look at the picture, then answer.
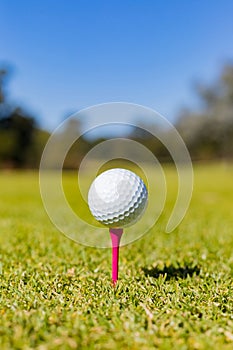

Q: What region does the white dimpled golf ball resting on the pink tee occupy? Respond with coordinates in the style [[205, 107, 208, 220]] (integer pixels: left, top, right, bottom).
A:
[[88, 168, 148, 228]]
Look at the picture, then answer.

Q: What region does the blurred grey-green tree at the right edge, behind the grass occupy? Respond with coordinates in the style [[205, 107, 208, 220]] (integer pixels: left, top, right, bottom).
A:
[[177, 65, 233, 159]]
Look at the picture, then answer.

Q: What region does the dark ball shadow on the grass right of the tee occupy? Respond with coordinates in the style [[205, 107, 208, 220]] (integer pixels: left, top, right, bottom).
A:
[[143, 264, 200, 281]]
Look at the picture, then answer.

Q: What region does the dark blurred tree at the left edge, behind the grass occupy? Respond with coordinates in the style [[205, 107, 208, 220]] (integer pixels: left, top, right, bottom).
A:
[[0, 69, 49, 168]]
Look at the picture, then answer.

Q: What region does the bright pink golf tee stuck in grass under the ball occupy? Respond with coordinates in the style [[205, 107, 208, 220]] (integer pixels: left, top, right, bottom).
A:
[[109, 228, 123, 286]]
